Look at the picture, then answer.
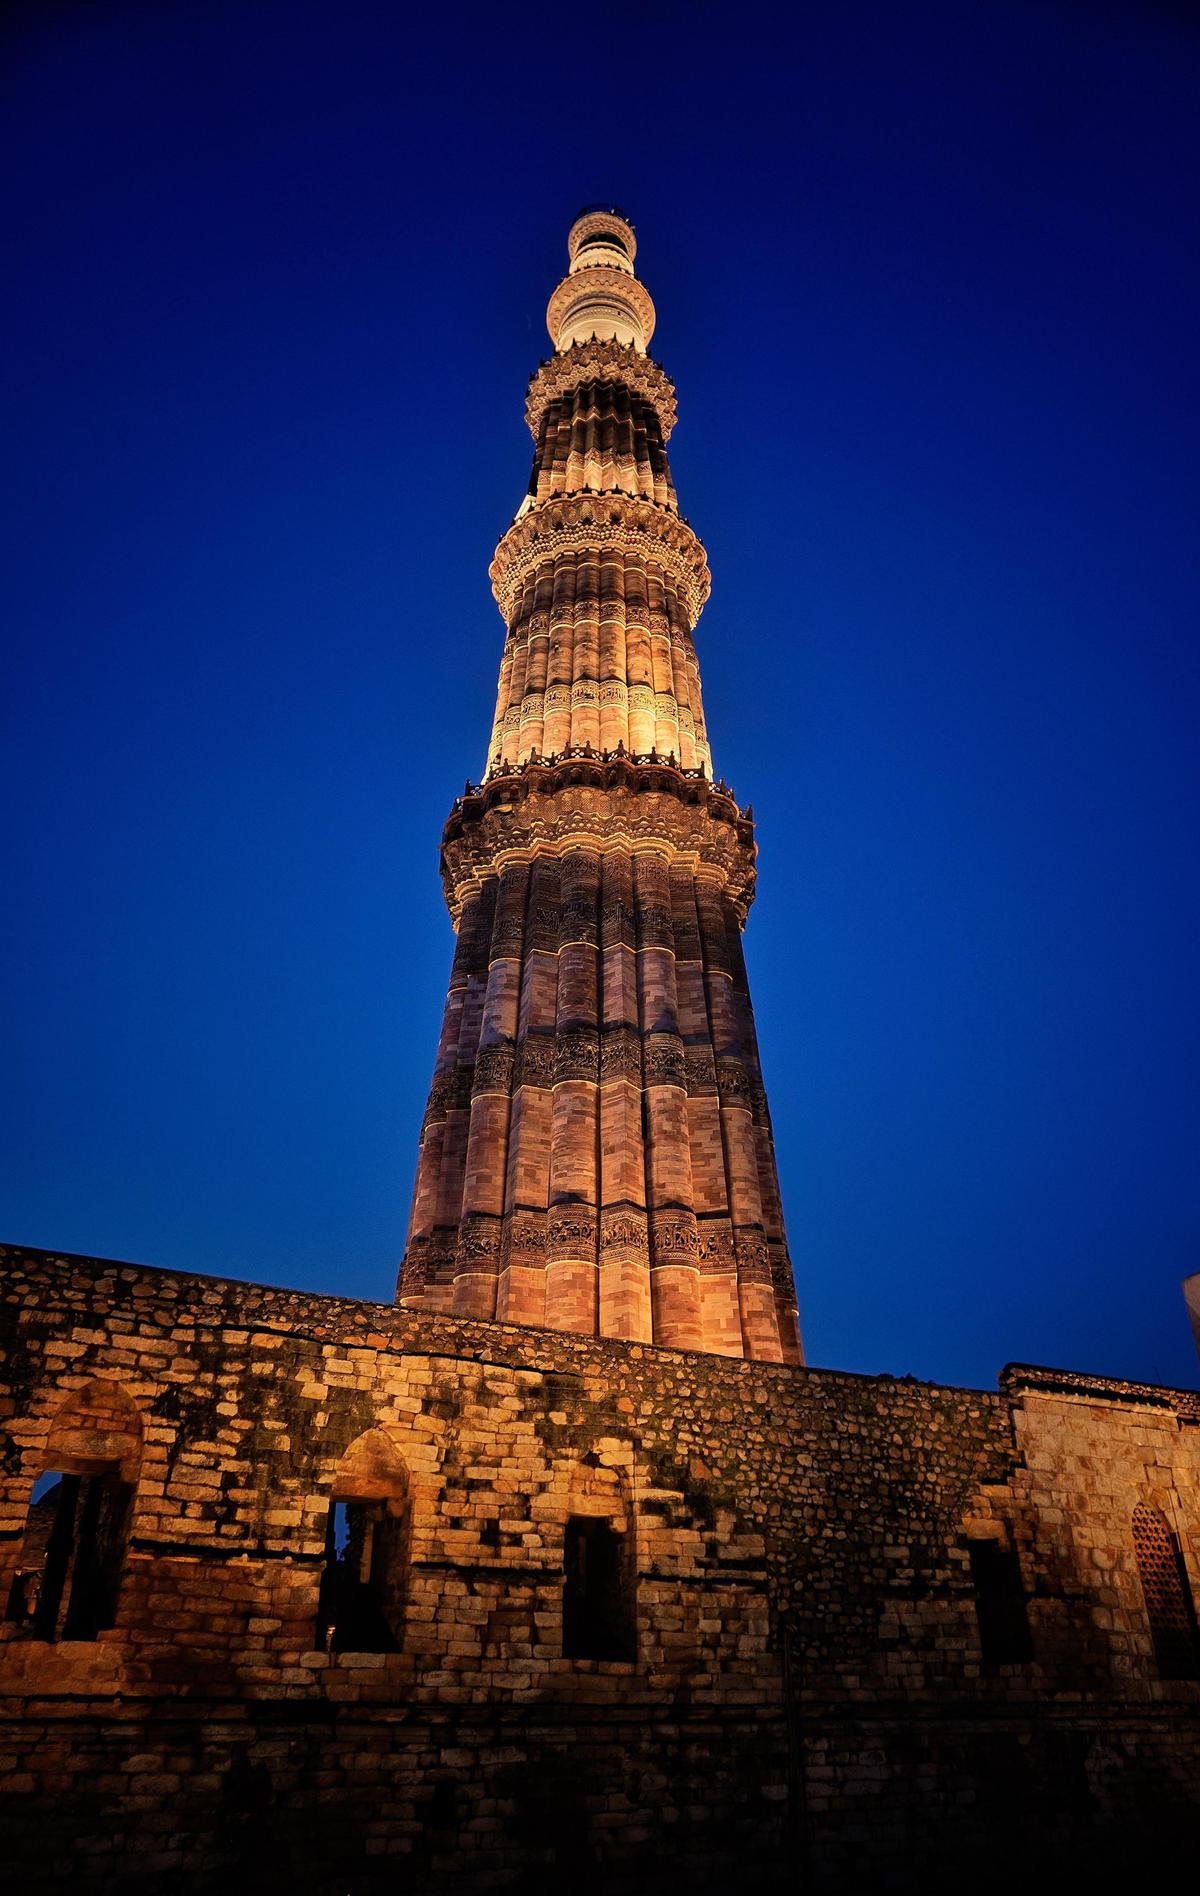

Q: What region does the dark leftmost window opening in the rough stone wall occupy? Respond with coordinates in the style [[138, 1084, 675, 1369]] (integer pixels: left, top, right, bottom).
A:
[[6, 1469, 133, 1640]]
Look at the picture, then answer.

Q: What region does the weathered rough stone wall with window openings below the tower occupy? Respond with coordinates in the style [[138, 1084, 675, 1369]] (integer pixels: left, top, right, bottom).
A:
[[0, 1251, 1200, 1892]]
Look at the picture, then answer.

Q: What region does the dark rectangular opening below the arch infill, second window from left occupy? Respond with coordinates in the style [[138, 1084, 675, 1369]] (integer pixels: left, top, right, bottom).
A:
[[317, 1502, 404, 1653]]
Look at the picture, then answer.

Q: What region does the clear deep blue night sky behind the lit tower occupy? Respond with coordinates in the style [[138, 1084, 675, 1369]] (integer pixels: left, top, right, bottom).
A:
[[0, 0, 1200, 1386]]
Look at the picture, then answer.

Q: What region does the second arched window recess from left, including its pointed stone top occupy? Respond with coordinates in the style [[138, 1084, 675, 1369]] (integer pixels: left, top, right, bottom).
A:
[[317, 1428, 411, 1653]]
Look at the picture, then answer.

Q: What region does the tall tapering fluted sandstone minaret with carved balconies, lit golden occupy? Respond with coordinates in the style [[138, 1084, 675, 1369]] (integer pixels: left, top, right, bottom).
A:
[[400, 209, 802, 1363]]
